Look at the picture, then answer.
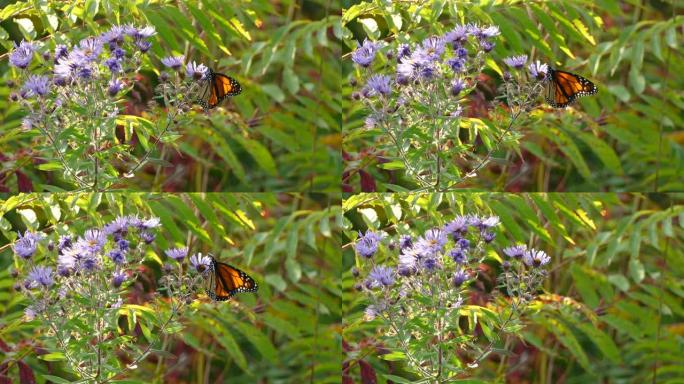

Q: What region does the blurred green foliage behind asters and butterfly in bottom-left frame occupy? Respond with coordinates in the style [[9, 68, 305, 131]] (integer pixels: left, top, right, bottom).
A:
[[0, 193, 342, 384]]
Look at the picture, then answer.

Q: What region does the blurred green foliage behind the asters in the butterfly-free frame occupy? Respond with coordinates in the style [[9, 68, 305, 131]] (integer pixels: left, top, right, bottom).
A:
[[342, 193, 684, 384]]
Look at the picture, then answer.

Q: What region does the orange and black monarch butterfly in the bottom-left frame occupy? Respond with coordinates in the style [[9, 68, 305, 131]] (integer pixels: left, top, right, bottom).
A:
[[205, 255, 259, 301]]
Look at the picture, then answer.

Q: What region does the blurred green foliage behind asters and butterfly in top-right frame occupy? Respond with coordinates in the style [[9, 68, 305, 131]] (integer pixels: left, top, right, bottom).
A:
[[342, 0, 684, 192]]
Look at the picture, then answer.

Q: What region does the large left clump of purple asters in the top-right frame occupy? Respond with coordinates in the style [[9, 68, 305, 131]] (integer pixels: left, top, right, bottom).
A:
[[350, 24, 501, 189]]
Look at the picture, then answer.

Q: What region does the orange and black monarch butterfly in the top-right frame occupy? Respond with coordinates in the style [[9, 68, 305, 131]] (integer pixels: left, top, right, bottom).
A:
[[546, 69, 598, 108]]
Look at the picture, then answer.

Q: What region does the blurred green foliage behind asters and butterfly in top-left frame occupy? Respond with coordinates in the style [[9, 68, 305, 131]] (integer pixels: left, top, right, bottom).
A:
[[0, 0, 341, 192]]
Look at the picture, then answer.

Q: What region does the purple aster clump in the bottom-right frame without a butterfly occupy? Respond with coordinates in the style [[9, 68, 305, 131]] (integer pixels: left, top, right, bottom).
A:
[[351, 213, 550, 374]]
